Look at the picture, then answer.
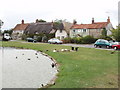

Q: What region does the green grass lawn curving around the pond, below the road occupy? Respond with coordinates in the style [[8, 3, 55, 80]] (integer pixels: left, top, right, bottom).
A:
[[2, 41, 118, 88]]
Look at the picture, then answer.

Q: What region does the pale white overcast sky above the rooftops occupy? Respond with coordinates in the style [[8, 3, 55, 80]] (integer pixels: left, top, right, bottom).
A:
[[0, 0, 119, 30]]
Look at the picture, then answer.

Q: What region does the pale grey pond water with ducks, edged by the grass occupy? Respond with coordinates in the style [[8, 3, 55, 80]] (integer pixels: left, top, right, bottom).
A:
[[0, 48, 57, 88]]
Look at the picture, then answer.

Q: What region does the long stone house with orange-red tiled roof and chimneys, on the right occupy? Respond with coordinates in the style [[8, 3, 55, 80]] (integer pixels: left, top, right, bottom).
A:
[[70, 17, 113, 38]]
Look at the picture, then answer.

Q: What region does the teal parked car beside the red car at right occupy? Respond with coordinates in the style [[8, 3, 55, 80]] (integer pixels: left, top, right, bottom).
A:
[[94, 39, 113, 48]]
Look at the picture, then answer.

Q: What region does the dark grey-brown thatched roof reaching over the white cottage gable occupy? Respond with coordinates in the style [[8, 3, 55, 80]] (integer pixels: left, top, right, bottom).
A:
[[24, 22, 64, 34]]
